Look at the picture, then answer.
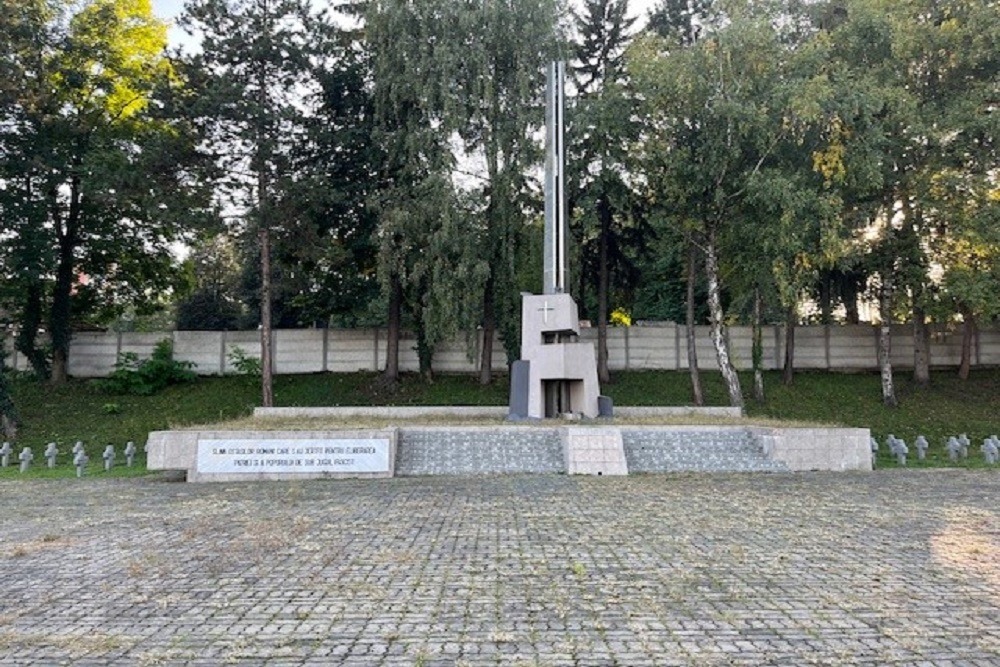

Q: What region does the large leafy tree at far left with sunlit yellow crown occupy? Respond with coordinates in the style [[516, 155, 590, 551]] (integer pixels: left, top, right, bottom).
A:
[[0, 0, 203, 383]]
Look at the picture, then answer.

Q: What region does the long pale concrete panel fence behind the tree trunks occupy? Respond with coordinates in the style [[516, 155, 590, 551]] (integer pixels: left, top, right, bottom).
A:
[[4, 323, 1000, 377]]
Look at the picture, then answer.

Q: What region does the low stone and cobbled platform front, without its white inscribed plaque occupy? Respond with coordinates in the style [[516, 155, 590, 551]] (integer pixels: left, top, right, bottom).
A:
[[147, 426, 872, 481]]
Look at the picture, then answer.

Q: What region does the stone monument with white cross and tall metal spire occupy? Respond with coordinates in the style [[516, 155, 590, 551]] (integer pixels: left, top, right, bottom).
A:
[[508, 62, 611, 419]]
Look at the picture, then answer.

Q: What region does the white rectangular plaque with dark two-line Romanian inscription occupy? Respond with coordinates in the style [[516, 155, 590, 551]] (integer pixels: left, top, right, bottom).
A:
[[196, 438, 391, 475]]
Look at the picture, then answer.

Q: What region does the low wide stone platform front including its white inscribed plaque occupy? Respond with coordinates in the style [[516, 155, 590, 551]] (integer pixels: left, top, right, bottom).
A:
[[147, 409, 872, 482]]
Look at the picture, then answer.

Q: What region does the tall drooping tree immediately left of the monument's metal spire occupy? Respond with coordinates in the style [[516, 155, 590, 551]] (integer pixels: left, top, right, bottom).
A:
[[453, 0, 558, 384]]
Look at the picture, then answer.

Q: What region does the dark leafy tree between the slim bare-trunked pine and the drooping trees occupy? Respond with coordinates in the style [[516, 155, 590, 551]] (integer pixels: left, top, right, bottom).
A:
[[288, 30, 383, 326]]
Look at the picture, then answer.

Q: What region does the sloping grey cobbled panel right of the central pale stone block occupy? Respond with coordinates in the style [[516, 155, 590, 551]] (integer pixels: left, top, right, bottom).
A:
[[621, 426, 788, 473]]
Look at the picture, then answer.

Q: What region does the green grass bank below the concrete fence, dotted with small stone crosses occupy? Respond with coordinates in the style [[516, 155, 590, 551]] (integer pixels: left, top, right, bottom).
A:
[[0, 369, 1000, 478]]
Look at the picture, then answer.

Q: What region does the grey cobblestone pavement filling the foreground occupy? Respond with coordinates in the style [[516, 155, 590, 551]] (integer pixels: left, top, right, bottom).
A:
[[0, 471, 1000, 667]]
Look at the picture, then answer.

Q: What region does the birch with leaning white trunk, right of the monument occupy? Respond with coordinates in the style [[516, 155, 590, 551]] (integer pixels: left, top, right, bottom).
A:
[[630, 6, 804, 406]]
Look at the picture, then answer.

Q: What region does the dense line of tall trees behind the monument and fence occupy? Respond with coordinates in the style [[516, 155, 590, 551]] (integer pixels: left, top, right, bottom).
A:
[[0, 0, 1000, 412]]
